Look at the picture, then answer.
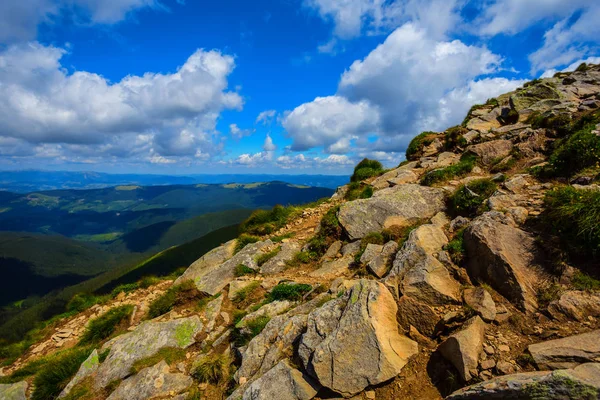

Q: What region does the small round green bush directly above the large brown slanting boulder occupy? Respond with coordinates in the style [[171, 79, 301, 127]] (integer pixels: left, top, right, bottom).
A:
[[448, 179, 497, 216]]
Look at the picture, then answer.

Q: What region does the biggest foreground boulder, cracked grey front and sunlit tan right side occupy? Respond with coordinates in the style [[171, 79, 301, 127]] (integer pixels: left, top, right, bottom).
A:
[[298, 280, 418, 397]]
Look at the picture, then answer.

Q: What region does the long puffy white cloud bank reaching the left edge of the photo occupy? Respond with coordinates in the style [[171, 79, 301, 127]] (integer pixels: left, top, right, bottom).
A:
[[0, 43, 243, 162]]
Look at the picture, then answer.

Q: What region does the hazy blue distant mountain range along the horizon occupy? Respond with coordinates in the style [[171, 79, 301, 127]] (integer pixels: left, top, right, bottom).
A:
[[0, 170, 348, 193]]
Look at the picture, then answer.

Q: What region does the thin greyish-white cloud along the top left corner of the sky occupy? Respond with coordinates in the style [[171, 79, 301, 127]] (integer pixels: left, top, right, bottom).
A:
[[0, 0, 166, 43]]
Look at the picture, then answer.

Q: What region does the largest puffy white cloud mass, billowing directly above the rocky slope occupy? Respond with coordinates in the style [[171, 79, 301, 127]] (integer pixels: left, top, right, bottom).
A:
[[283, 24, 522, 154]]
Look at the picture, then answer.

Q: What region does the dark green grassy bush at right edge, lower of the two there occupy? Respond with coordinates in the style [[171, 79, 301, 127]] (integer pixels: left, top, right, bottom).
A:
[[542, 186, 600, 257]]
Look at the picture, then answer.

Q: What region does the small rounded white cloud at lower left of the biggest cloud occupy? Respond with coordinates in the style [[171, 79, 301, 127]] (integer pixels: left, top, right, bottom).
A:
[[282, 96, 379, 150]]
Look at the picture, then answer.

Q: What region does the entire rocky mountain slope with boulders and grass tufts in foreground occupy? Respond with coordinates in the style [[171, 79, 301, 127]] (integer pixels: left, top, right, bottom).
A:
[[0, 65, 600, 400]]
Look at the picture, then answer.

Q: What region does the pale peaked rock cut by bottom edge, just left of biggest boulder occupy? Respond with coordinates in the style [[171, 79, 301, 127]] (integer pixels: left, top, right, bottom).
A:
[[242, 360, 319, 400]]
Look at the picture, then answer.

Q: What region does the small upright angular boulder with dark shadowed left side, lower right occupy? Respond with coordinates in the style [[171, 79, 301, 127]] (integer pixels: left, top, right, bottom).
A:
[[438, 316, 485, 382]]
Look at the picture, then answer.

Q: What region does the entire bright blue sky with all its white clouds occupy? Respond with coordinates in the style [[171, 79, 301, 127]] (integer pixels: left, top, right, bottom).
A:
[[0, 0, 600, 174]]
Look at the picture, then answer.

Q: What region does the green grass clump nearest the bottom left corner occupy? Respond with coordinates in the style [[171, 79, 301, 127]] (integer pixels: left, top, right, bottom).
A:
[[31, 347, 92, 400]]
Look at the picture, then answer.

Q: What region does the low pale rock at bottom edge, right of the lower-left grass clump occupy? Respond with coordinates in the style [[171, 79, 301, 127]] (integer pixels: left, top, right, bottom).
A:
[[107, 361, 193, 400]]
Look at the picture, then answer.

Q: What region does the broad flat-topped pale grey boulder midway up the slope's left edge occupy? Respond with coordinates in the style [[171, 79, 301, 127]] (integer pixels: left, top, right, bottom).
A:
[[338, 184, 445, 240]]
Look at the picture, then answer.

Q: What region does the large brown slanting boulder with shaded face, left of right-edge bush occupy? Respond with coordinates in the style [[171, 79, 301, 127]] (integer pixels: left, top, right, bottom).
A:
[[464, 212, 538, 311]]
